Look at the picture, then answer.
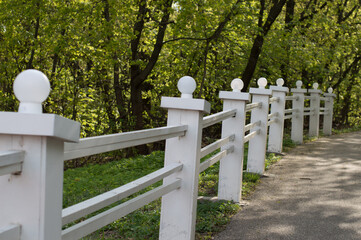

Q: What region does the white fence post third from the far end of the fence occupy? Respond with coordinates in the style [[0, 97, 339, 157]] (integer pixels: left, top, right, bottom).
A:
[[291, 80, 307, 144]]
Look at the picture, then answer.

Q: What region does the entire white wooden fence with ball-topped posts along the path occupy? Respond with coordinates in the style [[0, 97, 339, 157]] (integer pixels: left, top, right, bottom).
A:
[[0, 70, 334, 240]]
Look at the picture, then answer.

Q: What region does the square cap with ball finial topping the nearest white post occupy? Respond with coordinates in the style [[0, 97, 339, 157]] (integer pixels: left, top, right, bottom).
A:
[[0, 69, 80, 142]]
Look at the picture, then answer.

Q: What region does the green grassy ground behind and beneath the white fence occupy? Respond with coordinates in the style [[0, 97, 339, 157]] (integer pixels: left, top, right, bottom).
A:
[[63, 131, 330, 240]]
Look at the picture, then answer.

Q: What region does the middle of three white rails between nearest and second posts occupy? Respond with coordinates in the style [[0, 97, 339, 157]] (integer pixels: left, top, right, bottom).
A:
[[62, 163, 183, 225]]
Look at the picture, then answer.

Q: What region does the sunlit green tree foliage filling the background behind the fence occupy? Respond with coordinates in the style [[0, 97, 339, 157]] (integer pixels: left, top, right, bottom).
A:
[[0, 0, 361, 137]]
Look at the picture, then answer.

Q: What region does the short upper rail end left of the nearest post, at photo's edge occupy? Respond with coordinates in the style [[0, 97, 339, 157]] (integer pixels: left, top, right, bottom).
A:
[[0, 151, 25, 176]]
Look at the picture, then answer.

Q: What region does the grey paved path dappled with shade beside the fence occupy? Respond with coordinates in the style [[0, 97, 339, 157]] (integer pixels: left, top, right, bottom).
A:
[[214, 132, 361, 240]]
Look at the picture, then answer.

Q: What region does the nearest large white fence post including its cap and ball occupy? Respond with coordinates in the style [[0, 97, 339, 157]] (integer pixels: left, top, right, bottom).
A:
[[0, 70, 80, 240]]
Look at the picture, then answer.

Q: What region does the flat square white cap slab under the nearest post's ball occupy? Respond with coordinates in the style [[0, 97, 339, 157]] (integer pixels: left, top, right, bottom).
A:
[[0, 112, 80, 142]]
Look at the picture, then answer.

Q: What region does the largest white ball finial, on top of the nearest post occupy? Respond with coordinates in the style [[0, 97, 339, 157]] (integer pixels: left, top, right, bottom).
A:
[[13, 69, 50, 113]]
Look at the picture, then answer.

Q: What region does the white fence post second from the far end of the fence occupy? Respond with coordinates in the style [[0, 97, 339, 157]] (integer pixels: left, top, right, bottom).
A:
[[308, 83, 321, 137]]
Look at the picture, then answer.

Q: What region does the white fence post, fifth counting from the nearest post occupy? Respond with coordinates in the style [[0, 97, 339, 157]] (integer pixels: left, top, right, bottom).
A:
[[268, 78, 289, 153]]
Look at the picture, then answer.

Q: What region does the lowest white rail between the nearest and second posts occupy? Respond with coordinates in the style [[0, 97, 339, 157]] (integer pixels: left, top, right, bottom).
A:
[[62, 179, 181, 240]]
